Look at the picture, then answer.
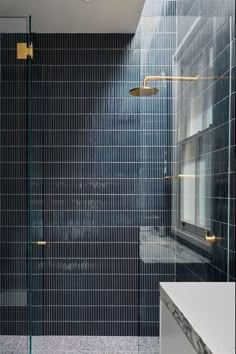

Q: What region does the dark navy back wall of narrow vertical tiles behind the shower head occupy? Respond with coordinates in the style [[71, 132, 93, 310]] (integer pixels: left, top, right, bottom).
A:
[[1, 1, 176, 335]]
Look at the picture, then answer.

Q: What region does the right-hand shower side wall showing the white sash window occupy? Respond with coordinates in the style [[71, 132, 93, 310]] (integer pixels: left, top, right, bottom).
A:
[[171, 1, 235, 281]]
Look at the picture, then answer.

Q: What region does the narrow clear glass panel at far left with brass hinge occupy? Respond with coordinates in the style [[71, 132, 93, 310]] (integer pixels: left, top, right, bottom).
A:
[[0, 17, 32, 353]]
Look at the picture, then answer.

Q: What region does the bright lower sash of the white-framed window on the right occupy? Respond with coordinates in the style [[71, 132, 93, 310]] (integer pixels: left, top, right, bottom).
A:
[[179, 134, 211, 235]]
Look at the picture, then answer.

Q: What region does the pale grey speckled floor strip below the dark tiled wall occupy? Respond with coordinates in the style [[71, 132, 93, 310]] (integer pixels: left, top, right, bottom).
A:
[[0, 336, 159, 354]]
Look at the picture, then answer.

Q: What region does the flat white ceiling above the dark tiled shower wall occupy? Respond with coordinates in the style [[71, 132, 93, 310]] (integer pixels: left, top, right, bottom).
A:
[[0, 0, 145, 33]]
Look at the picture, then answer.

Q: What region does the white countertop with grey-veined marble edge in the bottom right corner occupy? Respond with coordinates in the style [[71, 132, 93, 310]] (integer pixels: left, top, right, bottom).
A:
[[161, 282, 235, 354]]
